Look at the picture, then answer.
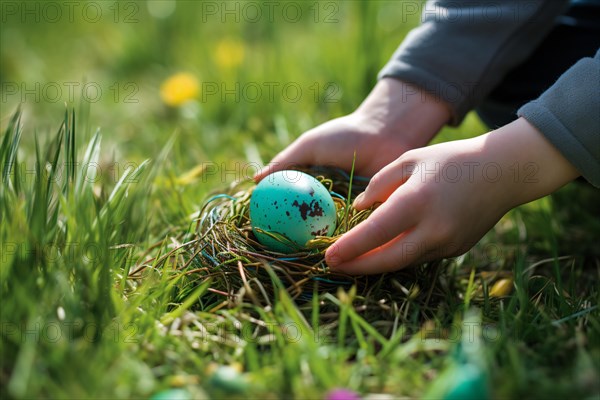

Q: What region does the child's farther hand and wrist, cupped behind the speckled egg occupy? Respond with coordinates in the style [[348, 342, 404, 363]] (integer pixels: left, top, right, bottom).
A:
[[255, 78, 449, 181]]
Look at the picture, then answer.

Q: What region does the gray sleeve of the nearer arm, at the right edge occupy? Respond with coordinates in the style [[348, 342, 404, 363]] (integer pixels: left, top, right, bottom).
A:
[[517, 50, 600, 187]]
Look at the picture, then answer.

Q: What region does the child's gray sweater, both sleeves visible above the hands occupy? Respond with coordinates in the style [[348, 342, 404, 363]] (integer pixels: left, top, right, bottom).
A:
[[379, 0, 600, 187]]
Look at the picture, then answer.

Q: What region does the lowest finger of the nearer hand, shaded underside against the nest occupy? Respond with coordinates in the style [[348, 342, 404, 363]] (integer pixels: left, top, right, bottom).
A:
[[330, 228, 431, 275]]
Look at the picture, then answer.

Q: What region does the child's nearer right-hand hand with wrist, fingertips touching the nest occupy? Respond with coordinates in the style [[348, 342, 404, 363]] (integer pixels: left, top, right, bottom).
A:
[[325, 118, 578, 274]]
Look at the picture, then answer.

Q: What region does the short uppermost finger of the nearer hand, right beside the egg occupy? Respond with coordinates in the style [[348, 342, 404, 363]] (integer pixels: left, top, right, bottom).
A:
[[352, 159, 415, 210]]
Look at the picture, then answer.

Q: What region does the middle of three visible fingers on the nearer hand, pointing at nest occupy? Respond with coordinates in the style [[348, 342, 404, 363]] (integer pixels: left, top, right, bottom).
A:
[[325, 187, 419, 267]]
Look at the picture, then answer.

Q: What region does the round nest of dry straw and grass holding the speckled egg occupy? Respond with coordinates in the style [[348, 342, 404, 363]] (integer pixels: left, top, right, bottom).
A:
[[130, 167, 446, 318]]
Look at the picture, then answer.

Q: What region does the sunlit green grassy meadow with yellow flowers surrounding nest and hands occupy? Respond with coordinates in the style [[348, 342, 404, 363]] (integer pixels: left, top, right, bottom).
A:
[[0, 0, 600, 399]]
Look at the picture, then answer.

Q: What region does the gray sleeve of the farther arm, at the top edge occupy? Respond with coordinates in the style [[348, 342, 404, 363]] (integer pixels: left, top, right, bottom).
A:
[[378, 0, 568, 125]]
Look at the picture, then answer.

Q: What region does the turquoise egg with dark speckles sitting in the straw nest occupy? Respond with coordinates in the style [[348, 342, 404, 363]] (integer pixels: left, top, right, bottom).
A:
[[250, 170, 337, 253]]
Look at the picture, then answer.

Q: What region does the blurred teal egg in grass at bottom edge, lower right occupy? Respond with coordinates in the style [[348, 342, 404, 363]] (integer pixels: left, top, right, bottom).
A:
[[444, 363, 490, 400]]
